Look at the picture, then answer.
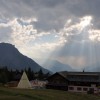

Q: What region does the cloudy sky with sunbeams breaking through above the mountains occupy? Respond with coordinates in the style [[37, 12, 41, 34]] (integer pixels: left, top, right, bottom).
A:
[[0, 0, 100, 68]]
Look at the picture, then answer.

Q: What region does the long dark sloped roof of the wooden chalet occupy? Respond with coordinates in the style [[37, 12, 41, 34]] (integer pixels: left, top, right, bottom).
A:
[[58, 71, 100, 82]]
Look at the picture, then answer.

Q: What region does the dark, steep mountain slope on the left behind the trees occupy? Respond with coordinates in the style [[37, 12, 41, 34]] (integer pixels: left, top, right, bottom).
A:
[[0, 43, 48, 73]]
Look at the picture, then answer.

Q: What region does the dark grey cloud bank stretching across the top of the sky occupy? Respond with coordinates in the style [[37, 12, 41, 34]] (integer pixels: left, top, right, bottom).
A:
[[0, 0, 100, 31]]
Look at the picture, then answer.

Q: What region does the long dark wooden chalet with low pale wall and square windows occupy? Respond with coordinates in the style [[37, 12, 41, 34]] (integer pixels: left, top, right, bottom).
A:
[[46, 71, 100, 92]]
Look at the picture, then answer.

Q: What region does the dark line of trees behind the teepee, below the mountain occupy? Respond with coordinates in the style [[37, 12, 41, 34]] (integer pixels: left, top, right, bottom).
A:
[[0, 67, 50, 84]]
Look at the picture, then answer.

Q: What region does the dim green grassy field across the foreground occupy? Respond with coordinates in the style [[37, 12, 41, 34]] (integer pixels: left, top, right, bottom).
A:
[[0, 87, 100, 100]]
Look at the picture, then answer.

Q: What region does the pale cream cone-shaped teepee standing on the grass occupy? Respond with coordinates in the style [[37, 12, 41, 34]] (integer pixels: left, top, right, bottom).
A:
[[17, 72, 32, 89]]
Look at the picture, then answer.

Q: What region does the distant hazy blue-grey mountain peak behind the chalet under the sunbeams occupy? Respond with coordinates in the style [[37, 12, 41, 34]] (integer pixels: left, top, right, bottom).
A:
[[43, 60, 74, 73]]
